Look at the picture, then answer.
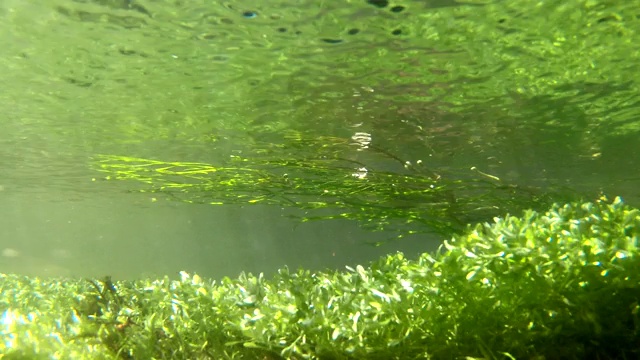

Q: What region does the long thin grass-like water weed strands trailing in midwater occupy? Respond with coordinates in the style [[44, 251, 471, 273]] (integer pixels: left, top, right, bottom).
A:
[[94, 131, 580, 237]]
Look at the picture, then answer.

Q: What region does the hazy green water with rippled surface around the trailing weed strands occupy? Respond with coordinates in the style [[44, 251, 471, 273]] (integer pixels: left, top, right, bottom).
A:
[[0, 0, 640, 278]]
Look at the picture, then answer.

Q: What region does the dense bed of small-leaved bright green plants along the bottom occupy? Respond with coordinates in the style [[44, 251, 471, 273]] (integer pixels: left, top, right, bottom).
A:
[[0, 199, 640, 359]]
